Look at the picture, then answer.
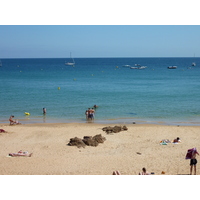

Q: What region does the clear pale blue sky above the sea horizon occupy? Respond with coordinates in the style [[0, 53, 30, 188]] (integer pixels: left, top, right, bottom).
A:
[[0, 25, 200, 58]]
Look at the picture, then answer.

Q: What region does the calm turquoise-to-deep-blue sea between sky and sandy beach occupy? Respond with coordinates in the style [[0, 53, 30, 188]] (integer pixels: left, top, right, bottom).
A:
[[0, 57, 200, 124]]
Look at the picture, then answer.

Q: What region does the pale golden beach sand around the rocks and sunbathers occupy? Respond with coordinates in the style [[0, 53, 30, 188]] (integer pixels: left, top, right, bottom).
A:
[[0, 123, 200, 175]]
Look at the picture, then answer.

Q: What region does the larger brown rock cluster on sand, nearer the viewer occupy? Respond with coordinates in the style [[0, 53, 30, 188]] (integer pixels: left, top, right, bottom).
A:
[[68, 134, 106, 148]]
